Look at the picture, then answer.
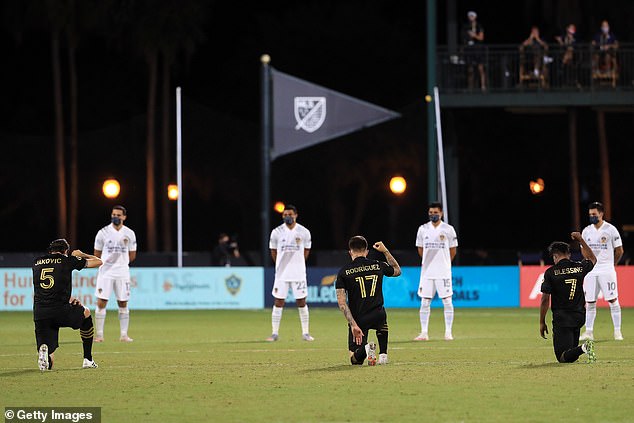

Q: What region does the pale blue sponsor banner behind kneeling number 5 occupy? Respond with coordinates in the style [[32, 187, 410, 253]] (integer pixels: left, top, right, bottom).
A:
[[0, 267, 264, 311]]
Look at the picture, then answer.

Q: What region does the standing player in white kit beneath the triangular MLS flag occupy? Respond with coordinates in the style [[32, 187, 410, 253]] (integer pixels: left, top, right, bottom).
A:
[[266, 204, 314, 342]]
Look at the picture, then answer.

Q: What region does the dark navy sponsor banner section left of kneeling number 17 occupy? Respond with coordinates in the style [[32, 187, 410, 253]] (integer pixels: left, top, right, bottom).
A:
[[264, 267, 339, 308]]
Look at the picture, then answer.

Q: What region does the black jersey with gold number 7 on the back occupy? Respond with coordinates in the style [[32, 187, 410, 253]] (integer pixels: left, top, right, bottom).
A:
[[542, 259, 594, 327]]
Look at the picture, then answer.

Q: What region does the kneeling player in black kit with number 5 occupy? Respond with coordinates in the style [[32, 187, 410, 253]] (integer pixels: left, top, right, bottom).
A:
[[33, 239, 101, 371]]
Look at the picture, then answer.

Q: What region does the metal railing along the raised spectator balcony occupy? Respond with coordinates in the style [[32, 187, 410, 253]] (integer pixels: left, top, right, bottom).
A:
[[437, 43, 634, 93]]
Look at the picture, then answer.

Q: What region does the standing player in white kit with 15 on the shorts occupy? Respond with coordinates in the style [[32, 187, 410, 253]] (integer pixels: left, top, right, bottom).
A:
[[414, 202, 458, 341]]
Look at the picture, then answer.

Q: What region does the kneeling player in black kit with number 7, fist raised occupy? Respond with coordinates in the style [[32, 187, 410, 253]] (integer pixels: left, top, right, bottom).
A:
[[539, 232, 597, 363]]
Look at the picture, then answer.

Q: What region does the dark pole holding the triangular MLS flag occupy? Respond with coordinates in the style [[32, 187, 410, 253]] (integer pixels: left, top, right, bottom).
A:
[[260, 54, 272, 267]]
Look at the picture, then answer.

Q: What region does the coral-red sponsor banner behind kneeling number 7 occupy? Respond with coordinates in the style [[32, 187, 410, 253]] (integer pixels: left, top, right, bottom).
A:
[[520, 266, 634, 307]]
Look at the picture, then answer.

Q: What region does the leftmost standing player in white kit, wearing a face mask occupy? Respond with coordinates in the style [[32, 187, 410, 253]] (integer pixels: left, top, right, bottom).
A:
[[95, 206, 136, 342]]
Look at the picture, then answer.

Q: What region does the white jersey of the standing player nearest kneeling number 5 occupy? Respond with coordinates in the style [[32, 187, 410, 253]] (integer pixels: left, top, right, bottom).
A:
[[95, 224, 136, 279]]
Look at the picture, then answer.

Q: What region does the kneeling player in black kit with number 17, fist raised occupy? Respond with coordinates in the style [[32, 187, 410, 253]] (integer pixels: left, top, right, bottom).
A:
[[335, 236, 401, 366]]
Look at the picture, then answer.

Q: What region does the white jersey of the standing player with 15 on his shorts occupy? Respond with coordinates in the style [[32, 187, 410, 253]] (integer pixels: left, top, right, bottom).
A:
[[416, 222, 458, 279]]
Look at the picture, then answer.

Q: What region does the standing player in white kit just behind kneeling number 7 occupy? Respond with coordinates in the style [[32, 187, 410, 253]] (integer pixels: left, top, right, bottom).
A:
[[580, 202, 623, 341]]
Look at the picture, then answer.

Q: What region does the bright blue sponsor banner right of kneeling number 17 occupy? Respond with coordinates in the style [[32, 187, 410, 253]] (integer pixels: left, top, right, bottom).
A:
[[383, 266, 519, 308]]
